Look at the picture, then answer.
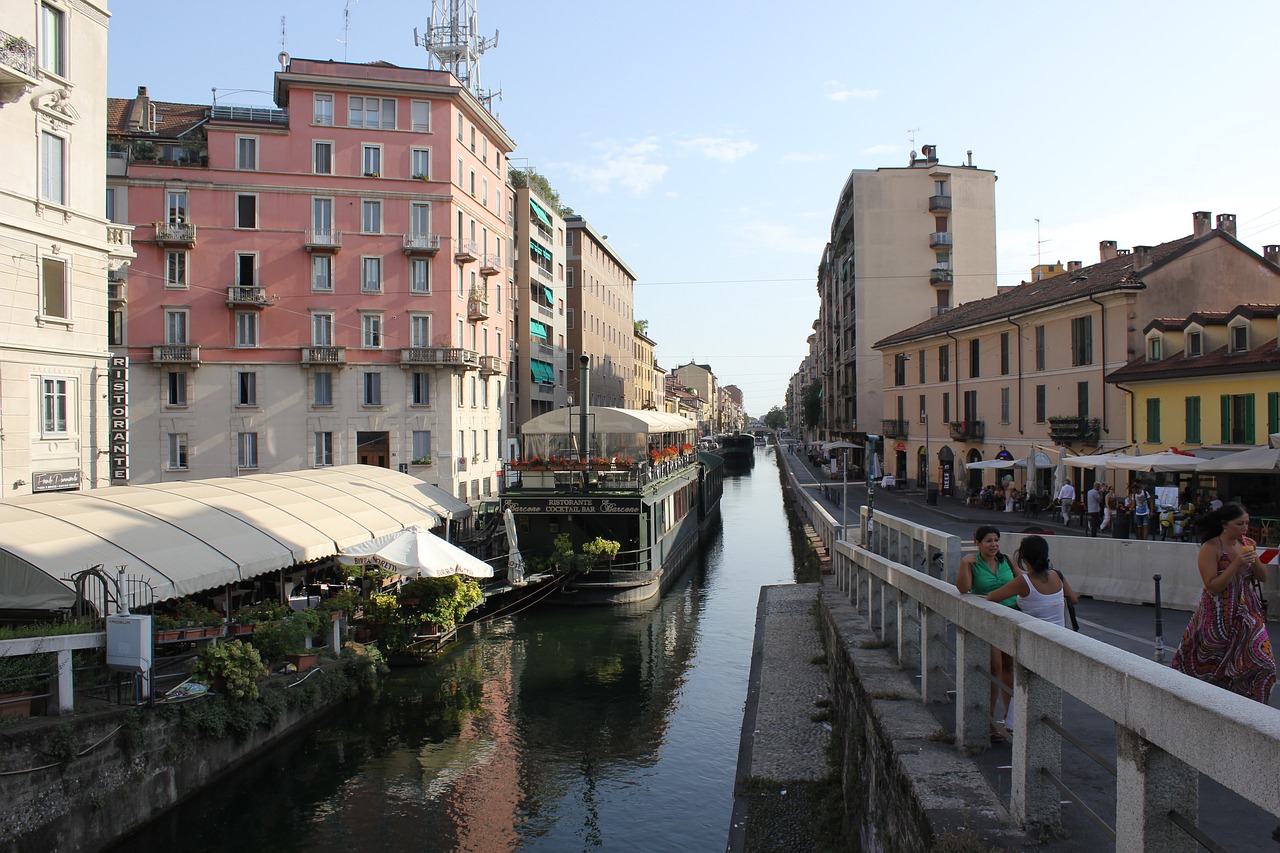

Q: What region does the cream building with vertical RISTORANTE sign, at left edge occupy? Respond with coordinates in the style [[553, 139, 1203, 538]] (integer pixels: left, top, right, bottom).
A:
[[0, 0, 133, 497]]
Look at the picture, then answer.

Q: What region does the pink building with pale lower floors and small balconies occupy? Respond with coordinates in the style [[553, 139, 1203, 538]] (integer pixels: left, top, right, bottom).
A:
[[108, 59, 513, 501]]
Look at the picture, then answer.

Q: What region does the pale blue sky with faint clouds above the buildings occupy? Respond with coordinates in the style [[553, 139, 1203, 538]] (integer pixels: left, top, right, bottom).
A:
[[108, 0, 1280, 416]]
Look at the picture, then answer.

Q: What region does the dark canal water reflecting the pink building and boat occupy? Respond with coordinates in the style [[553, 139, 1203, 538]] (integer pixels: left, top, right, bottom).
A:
[[116, 448, 796, 853]]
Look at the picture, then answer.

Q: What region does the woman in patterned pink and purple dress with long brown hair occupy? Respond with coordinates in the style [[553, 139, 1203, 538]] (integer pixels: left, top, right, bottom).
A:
[[1174, 503, 1276, 704]]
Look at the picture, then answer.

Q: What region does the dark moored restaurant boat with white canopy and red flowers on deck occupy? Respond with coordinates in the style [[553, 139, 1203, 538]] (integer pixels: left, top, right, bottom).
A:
[[502, 406, 723, 605]]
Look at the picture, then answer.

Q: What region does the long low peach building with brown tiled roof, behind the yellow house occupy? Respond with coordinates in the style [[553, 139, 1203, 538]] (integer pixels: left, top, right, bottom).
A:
[[874, 211, 1280, 489]]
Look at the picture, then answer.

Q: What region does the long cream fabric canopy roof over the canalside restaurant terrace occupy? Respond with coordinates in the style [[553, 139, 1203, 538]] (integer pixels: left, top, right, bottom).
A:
[[0, 465, 444, 610]]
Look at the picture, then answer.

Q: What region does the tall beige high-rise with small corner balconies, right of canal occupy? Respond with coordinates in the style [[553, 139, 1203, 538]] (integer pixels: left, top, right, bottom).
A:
[[814, 145, 996, 441]]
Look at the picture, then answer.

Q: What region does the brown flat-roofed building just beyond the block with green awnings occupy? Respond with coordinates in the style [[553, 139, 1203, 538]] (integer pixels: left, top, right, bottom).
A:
[[564, 215, 636, 407]]
